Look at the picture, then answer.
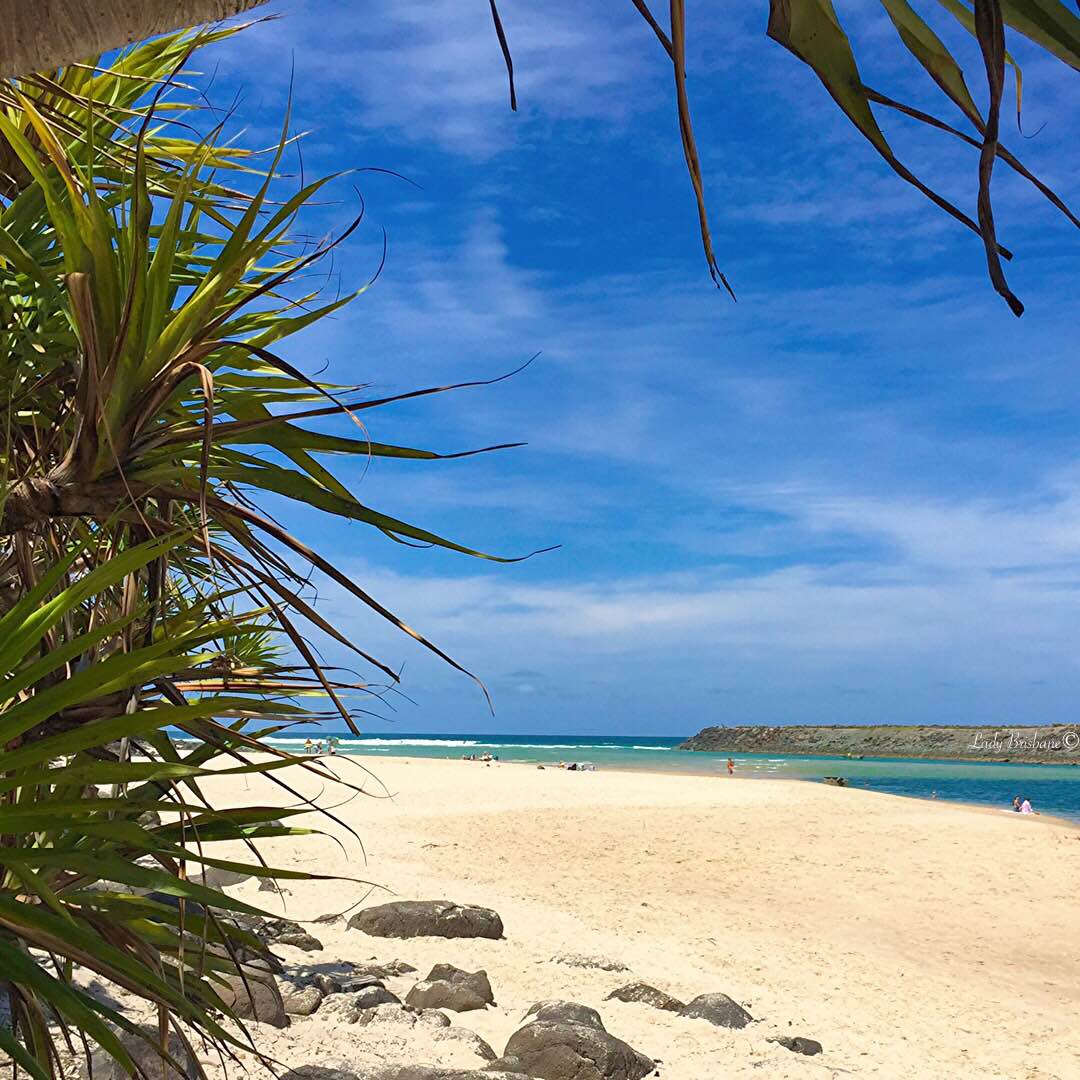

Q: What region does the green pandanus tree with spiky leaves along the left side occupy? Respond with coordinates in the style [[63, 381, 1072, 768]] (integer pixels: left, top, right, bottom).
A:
[[0, 28, 522, 1078]]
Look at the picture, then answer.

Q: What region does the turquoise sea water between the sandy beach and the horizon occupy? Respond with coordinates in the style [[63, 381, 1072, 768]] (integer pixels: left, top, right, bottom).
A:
[[263, 732, 1080, 821]]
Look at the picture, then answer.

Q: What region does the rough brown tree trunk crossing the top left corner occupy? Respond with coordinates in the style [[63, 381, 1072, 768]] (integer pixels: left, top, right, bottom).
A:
[[0, 0, 265, 78]]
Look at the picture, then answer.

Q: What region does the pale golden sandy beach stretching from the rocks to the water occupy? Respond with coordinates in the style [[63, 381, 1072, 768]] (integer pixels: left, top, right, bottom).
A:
[[194, 758, 1080, 1080]]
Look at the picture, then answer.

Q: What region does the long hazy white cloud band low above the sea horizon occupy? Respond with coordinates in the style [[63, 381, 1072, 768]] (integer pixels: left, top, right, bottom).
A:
[[308, 468, 1080, 693]]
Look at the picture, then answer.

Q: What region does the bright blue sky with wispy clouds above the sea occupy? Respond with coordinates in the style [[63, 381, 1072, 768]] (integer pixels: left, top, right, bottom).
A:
[[204, 0, 1080, 733]]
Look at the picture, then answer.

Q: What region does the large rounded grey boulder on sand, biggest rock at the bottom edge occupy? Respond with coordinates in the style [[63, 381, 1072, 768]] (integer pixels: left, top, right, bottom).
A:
[[503, 1021, 656, 1080]]
